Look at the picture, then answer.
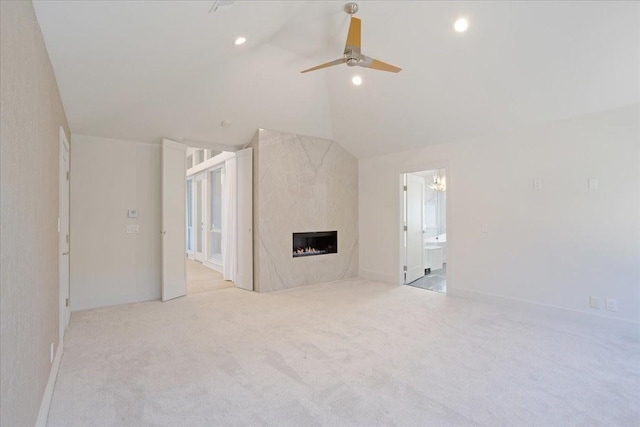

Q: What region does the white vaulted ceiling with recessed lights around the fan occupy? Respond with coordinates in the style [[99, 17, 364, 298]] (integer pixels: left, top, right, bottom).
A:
[[34, 0, 640, 158]]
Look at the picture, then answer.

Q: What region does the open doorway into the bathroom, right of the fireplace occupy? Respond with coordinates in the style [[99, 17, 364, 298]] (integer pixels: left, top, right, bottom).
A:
[[402, 168, 447, 293]]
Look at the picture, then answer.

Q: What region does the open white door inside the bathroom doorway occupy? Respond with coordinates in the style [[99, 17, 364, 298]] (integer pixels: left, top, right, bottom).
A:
[[405, 174, 425, 283]]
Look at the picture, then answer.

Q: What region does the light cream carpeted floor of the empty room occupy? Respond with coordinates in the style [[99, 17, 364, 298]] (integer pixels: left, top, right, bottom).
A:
[[48, 279, 640, 427]]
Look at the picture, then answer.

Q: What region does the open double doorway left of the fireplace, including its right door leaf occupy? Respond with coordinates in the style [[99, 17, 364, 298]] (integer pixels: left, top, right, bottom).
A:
[[181, 148, 253, 293]]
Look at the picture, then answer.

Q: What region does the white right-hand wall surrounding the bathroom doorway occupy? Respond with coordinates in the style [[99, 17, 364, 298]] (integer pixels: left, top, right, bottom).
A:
[[358, 104, 640, 322]]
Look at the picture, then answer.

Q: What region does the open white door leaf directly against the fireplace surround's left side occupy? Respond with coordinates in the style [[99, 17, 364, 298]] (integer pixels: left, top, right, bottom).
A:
[[236, 148, 253, 291]]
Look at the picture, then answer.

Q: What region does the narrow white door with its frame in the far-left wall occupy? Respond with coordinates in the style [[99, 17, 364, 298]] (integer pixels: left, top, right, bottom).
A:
[[58, 126, 71, 342]]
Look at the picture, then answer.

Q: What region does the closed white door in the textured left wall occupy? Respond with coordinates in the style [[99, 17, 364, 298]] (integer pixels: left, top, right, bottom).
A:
[[58, 126, 71, 339]]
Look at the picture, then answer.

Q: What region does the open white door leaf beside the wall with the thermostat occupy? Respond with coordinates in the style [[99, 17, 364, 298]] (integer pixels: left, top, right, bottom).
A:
[[162, 139, 187, 301]]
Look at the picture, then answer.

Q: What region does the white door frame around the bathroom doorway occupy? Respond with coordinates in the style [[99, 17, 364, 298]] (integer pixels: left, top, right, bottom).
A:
[[396, 160, 456, 294]]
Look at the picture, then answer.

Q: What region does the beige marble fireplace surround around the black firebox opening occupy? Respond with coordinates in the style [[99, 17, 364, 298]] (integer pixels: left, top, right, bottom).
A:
[[251, 129, 358, 292]]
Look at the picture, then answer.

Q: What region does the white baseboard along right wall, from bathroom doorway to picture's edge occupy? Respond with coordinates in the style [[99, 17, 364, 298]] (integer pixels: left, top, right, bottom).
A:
[[447, 289, 640, 338]]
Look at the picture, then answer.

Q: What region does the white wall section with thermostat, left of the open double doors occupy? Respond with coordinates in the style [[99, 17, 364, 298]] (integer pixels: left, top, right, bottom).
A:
[[71, 134, 161, 311]]
